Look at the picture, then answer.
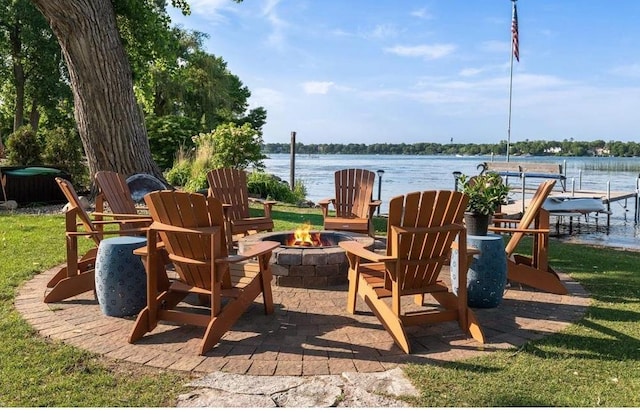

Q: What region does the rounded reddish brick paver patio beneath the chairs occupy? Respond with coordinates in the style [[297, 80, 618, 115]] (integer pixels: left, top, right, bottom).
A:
[[15, 268, 590, 375]]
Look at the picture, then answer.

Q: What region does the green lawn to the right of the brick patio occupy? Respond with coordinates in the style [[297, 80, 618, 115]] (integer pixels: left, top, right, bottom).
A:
[[407, 241, 640, 407]]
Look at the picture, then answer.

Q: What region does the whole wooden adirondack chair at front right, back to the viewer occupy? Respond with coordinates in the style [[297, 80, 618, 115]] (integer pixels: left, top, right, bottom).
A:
[[339, 191, 484, 354]]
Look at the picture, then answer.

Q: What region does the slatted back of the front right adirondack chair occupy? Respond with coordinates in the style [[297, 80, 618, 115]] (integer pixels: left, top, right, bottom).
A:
[[387, 190, 469, 295]]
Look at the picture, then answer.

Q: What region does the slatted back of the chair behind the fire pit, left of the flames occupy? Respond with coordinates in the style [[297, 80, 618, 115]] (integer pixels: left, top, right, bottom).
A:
[[207, 168, 249, 220]]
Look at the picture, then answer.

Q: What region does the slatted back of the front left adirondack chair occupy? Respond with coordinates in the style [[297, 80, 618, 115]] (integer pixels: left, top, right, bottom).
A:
[[144, 190, 227, 290]]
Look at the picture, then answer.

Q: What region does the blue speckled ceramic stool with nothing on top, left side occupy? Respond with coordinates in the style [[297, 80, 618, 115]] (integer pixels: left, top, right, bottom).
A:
[[95, 236, 147, 317]]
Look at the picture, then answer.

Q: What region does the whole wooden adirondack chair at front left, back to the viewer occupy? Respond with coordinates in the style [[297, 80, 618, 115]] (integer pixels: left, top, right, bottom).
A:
[[129, 190, 280, 355]]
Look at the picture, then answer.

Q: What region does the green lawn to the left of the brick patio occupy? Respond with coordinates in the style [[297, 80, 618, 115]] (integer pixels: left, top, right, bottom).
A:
[[0, 215, 187, 407]]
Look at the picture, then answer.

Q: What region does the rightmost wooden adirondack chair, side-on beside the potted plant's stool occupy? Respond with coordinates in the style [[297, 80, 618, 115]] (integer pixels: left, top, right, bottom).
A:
[[489, 180, 568, 295]]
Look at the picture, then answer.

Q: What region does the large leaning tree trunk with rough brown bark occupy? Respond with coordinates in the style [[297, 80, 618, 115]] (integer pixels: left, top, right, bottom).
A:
[[32, 0, 162, 178]]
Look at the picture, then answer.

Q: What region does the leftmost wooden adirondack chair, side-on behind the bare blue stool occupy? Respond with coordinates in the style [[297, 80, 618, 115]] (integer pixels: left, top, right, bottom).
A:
[[44, 177, 149, 303]]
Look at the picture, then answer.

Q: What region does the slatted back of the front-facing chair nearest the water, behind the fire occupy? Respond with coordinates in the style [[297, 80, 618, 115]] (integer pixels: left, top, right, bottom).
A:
[[334, 168, 376, 218]]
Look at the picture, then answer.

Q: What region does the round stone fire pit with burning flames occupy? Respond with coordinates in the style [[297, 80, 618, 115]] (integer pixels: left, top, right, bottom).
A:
[[238, 229, 374, 288]]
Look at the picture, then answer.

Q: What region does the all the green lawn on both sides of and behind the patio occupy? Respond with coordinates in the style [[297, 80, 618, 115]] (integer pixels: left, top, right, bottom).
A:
[[0, 205, 640, 407]]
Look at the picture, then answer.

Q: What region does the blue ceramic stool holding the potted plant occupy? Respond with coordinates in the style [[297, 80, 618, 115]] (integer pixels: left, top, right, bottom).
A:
[[451, 233, 507, 308]]
